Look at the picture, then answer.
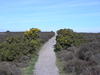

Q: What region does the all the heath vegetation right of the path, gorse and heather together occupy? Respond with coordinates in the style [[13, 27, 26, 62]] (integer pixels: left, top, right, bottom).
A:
[[55, 29, 100, 75]]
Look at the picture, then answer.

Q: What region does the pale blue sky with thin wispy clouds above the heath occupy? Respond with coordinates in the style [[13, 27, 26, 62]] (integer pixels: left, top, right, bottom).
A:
[[0, 0, 100, 32]]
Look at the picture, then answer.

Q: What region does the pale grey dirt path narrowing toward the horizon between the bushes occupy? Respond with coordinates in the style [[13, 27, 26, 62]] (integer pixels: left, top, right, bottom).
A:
[[34, 36, 59, 75]]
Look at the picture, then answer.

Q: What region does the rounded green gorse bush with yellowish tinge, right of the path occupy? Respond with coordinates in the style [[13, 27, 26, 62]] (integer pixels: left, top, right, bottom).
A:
[[55, 29, 85, 51]]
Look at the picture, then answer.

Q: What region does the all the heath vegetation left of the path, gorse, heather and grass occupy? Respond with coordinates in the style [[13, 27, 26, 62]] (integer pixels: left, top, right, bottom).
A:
[[0, 28, 54, 75]]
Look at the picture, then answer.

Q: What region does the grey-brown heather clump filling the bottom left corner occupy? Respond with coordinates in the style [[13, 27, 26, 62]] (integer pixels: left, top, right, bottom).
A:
[[0, 62, 22, 75]]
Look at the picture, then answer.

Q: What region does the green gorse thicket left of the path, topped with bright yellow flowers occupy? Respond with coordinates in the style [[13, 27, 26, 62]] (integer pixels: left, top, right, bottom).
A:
[[0, 28, 41, 61]]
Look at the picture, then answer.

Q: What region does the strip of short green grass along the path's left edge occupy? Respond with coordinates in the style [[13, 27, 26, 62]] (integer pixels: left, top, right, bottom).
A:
[[22, 55, 38, 75]]
